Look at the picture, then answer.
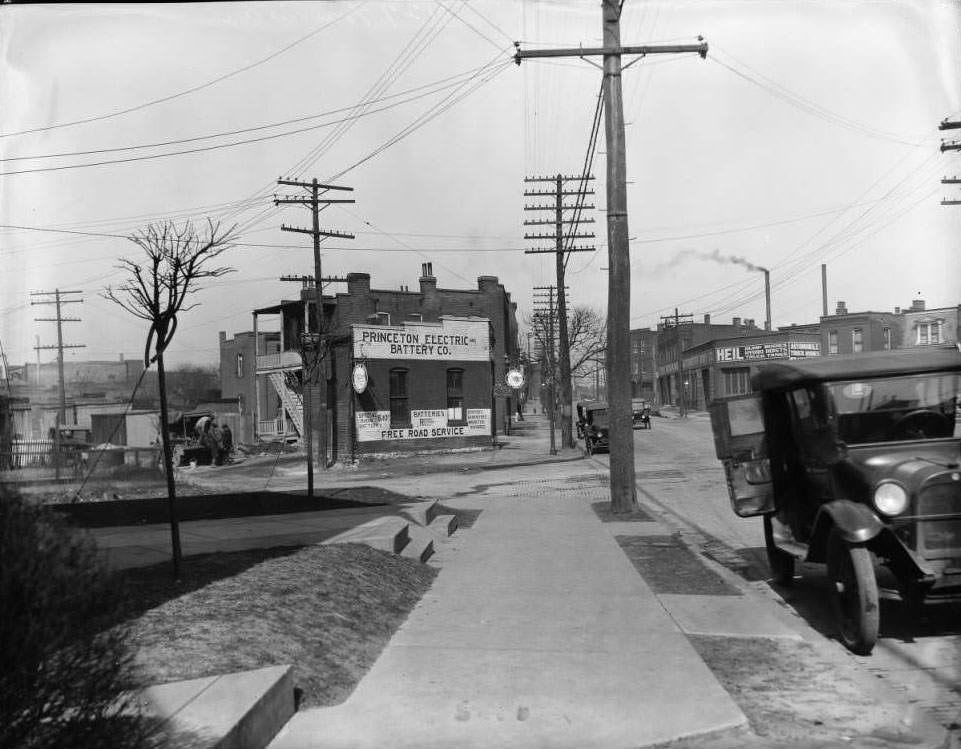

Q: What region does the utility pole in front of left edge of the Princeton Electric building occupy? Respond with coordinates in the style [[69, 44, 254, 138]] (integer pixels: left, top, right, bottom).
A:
[[274, 177, 355, 497]]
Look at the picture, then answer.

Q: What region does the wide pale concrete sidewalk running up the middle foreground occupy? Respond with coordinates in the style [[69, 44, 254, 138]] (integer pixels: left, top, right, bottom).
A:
[[270, 488, 746, 749]]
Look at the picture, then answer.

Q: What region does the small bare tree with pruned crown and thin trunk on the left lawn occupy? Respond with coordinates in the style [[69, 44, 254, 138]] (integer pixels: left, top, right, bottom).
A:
[[102, 219, 236, 580]]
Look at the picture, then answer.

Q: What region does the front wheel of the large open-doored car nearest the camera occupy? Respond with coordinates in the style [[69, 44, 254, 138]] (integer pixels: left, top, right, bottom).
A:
[[827, 528, 881, 655]]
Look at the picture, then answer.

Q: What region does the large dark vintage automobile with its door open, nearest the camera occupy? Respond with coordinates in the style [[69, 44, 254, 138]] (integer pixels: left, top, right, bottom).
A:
[[710, 347, 961, 655]]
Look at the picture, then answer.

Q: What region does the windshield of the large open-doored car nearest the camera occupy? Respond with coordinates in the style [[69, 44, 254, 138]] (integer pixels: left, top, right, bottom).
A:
[[826, 374, 961, 444]]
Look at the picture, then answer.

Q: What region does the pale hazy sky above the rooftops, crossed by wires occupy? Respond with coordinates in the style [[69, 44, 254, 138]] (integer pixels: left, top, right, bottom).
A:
[[0, 0, 961, 366]]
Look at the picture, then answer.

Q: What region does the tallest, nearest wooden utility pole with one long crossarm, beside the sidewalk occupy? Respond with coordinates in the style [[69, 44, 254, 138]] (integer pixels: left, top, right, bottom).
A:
[[514, 0, 707, 513]]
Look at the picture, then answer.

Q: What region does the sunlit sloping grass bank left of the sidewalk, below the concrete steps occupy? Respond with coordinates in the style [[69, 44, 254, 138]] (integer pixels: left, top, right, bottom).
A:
[[118, 544, 437, 707]]
